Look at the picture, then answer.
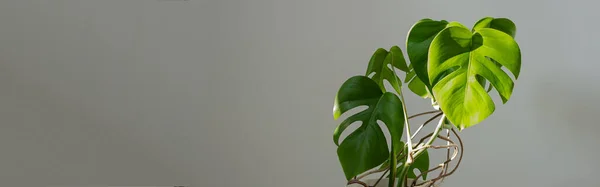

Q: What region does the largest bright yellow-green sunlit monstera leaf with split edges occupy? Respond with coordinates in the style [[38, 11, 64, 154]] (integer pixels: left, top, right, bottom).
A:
[[428, 23, 521, 129]]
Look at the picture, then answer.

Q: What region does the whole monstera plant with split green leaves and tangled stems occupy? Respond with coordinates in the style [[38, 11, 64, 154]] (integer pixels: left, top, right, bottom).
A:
[[333, 17, 521, 187]]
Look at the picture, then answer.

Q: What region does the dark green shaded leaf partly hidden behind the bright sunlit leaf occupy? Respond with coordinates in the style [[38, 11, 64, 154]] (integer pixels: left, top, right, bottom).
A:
[[406, 19, 448, 93]]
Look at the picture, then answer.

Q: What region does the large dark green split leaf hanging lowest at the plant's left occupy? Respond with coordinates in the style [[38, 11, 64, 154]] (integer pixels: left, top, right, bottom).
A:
[[333, 76, 404, 180]]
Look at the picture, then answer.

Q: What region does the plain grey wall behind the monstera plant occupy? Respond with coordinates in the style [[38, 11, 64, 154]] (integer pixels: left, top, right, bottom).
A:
[[0, 0, 600, 187]]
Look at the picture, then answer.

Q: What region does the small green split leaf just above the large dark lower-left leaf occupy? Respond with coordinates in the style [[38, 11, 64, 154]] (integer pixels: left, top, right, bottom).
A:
[[366, 46, 408, 92]]
